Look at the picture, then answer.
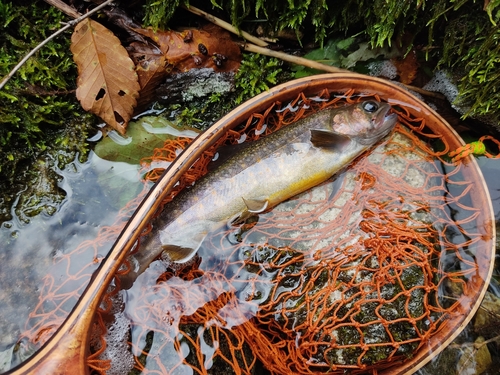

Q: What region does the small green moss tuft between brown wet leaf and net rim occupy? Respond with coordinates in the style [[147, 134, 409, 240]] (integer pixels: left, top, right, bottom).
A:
[[235, 54, 281, 104]]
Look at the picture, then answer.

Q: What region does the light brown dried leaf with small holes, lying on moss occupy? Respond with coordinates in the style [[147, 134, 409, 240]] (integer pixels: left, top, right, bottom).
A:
[[71, 19, 140, 134]]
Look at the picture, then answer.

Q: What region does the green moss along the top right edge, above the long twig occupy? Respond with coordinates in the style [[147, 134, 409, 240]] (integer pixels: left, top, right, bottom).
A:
[[200, 0, 500, 124]]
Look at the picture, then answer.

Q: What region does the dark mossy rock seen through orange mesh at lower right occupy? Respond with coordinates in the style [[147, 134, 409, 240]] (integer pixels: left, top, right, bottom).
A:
[[242, 247, 426, 365]]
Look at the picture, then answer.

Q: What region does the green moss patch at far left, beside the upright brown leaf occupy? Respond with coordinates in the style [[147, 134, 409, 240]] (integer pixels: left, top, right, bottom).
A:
[[0, 0, 94, 221]]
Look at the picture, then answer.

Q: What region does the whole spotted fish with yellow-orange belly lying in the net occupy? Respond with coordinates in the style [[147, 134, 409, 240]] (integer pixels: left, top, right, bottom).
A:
[[120, 100, 397, 289]]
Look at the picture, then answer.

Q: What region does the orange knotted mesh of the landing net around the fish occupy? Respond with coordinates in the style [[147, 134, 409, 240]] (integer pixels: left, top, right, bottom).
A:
[[20, 90, 492, 374]]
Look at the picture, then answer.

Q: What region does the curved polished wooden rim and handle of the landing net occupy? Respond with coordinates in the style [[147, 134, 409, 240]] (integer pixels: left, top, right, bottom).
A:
[[9, 73, 496, 375]]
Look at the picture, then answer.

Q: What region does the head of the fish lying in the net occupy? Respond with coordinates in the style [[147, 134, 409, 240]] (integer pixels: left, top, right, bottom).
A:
[[332, 100, 398, 145]]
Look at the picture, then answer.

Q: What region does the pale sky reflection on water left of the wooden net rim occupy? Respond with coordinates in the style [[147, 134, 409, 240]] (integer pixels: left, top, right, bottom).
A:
[[0, 154, 142, 371]]
